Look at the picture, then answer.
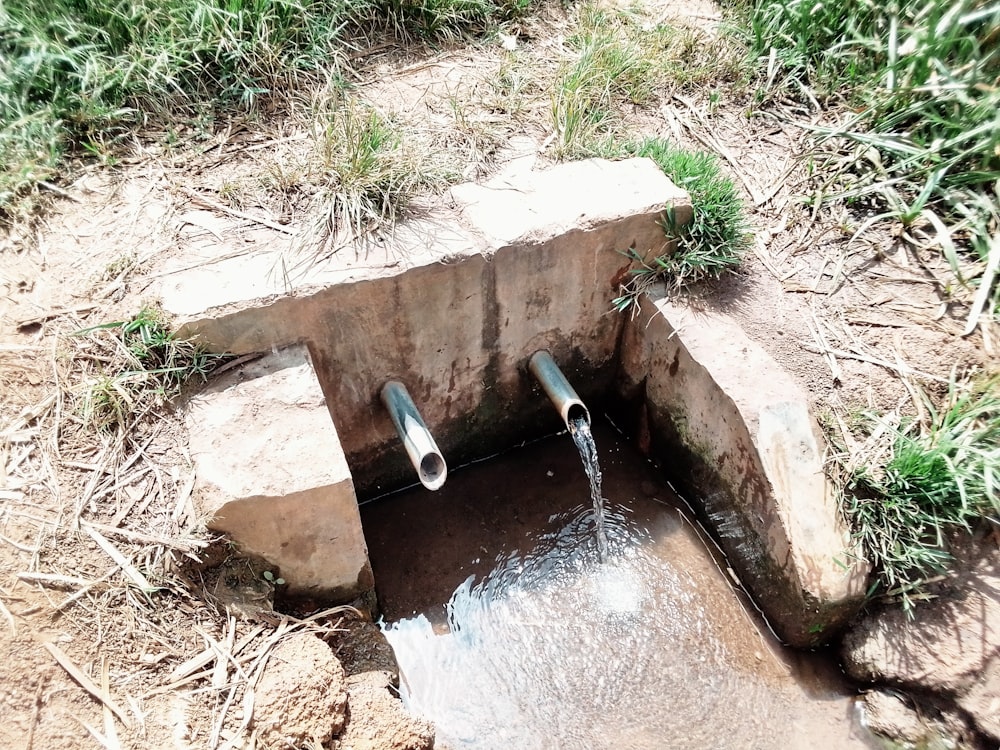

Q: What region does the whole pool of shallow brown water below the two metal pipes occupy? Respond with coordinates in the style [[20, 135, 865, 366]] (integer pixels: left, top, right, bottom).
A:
[[362, 420, 878, 750]]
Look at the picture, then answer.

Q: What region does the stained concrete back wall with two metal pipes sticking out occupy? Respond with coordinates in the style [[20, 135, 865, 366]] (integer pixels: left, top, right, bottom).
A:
[[174, 159, 690, 497]]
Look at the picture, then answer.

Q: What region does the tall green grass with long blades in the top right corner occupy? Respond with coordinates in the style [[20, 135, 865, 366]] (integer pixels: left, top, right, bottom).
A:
[[745, 0, 1000, 314]]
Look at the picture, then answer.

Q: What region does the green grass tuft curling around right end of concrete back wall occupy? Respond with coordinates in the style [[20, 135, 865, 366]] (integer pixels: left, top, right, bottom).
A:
[[602, 138, 750, 311]]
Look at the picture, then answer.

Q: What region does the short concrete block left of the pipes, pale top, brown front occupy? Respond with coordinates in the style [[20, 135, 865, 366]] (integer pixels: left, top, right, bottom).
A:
[[184, 346, 373, 601]]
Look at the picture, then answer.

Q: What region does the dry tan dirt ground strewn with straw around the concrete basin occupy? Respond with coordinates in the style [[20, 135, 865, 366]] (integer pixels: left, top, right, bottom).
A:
[[0, 1, 1000, 750]]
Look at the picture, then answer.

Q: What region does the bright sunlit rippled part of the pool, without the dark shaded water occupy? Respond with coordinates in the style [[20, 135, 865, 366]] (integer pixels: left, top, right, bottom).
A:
[[385, 508, 844, 750]]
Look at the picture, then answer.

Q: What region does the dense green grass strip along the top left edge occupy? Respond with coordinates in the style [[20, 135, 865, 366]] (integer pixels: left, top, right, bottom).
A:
[[0, 0, 530, 219]]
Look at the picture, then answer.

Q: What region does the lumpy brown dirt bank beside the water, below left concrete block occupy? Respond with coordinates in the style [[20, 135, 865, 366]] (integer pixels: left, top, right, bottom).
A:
[[182, 540, 434, 750]]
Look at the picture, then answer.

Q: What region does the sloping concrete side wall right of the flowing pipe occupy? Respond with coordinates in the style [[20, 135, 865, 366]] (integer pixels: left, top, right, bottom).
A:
[[622, 297, 868, 647]]
